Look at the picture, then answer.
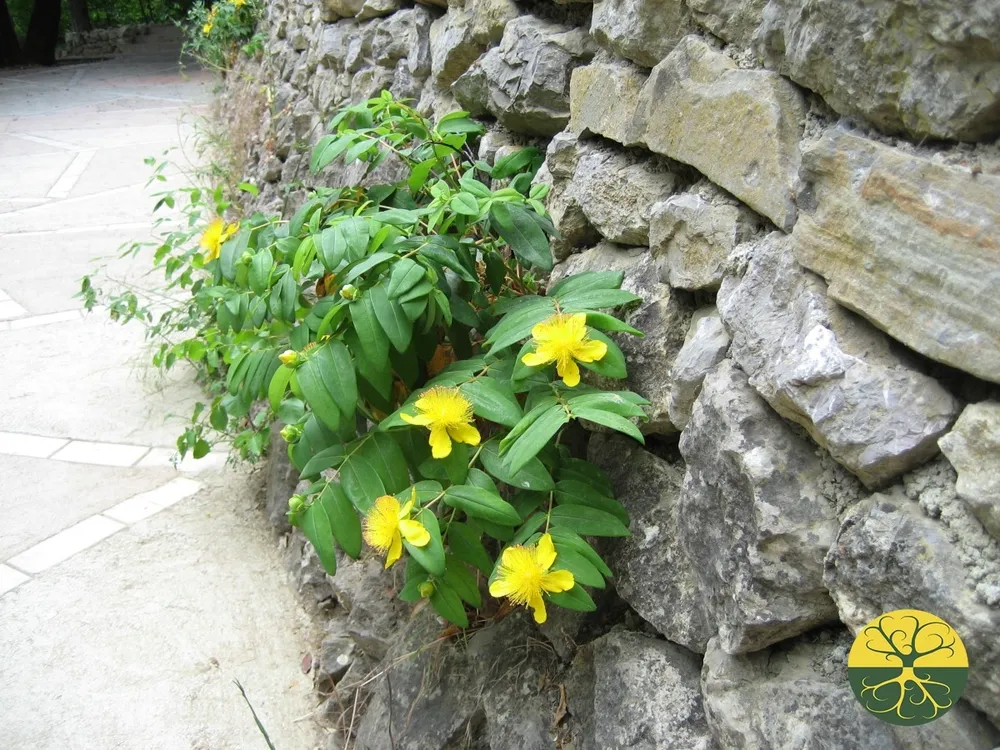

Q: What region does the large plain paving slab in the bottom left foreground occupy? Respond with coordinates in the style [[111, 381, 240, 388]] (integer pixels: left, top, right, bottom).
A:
[[0, 472, 316, 750]]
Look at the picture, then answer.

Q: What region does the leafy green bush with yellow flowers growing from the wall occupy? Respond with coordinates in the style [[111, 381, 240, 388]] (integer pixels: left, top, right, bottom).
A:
[[84, 93, 646, 627]]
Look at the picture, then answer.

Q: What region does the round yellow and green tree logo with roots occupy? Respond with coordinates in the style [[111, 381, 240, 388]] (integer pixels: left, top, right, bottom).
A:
[[847, 609, 969, 726]]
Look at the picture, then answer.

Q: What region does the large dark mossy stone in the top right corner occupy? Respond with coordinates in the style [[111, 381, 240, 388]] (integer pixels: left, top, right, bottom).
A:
[[755, 0, 1000, 140]]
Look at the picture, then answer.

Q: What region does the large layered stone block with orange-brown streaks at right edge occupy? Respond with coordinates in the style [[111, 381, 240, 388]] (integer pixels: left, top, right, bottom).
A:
[[794, 129, 1000, 382]]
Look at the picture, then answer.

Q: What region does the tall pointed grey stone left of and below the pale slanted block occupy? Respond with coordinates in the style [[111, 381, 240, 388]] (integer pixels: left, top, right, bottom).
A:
[[677, 360, 856, 654]]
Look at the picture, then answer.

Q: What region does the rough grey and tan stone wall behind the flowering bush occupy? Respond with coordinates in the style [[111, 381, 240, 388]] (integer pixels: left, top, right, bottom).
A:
[[228, 0, 1000, 750]]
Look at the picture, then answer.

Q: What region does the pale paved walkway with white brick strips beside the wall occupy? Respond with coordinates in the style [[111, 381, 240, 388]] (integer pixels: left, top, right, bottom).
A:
[[0, 29, 317, 750]]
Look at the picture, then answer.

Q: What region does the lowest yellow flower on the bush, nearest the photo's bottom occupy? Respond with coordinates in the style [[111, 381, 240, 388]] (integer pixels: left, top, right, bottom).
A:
[[490, 534, 576, 625]]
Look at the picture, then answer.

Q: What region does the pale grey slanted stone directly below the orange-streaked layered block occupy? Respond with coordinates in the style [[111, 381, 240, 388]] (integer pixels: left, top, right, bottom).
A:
[[718, 233, 960, 487]]
